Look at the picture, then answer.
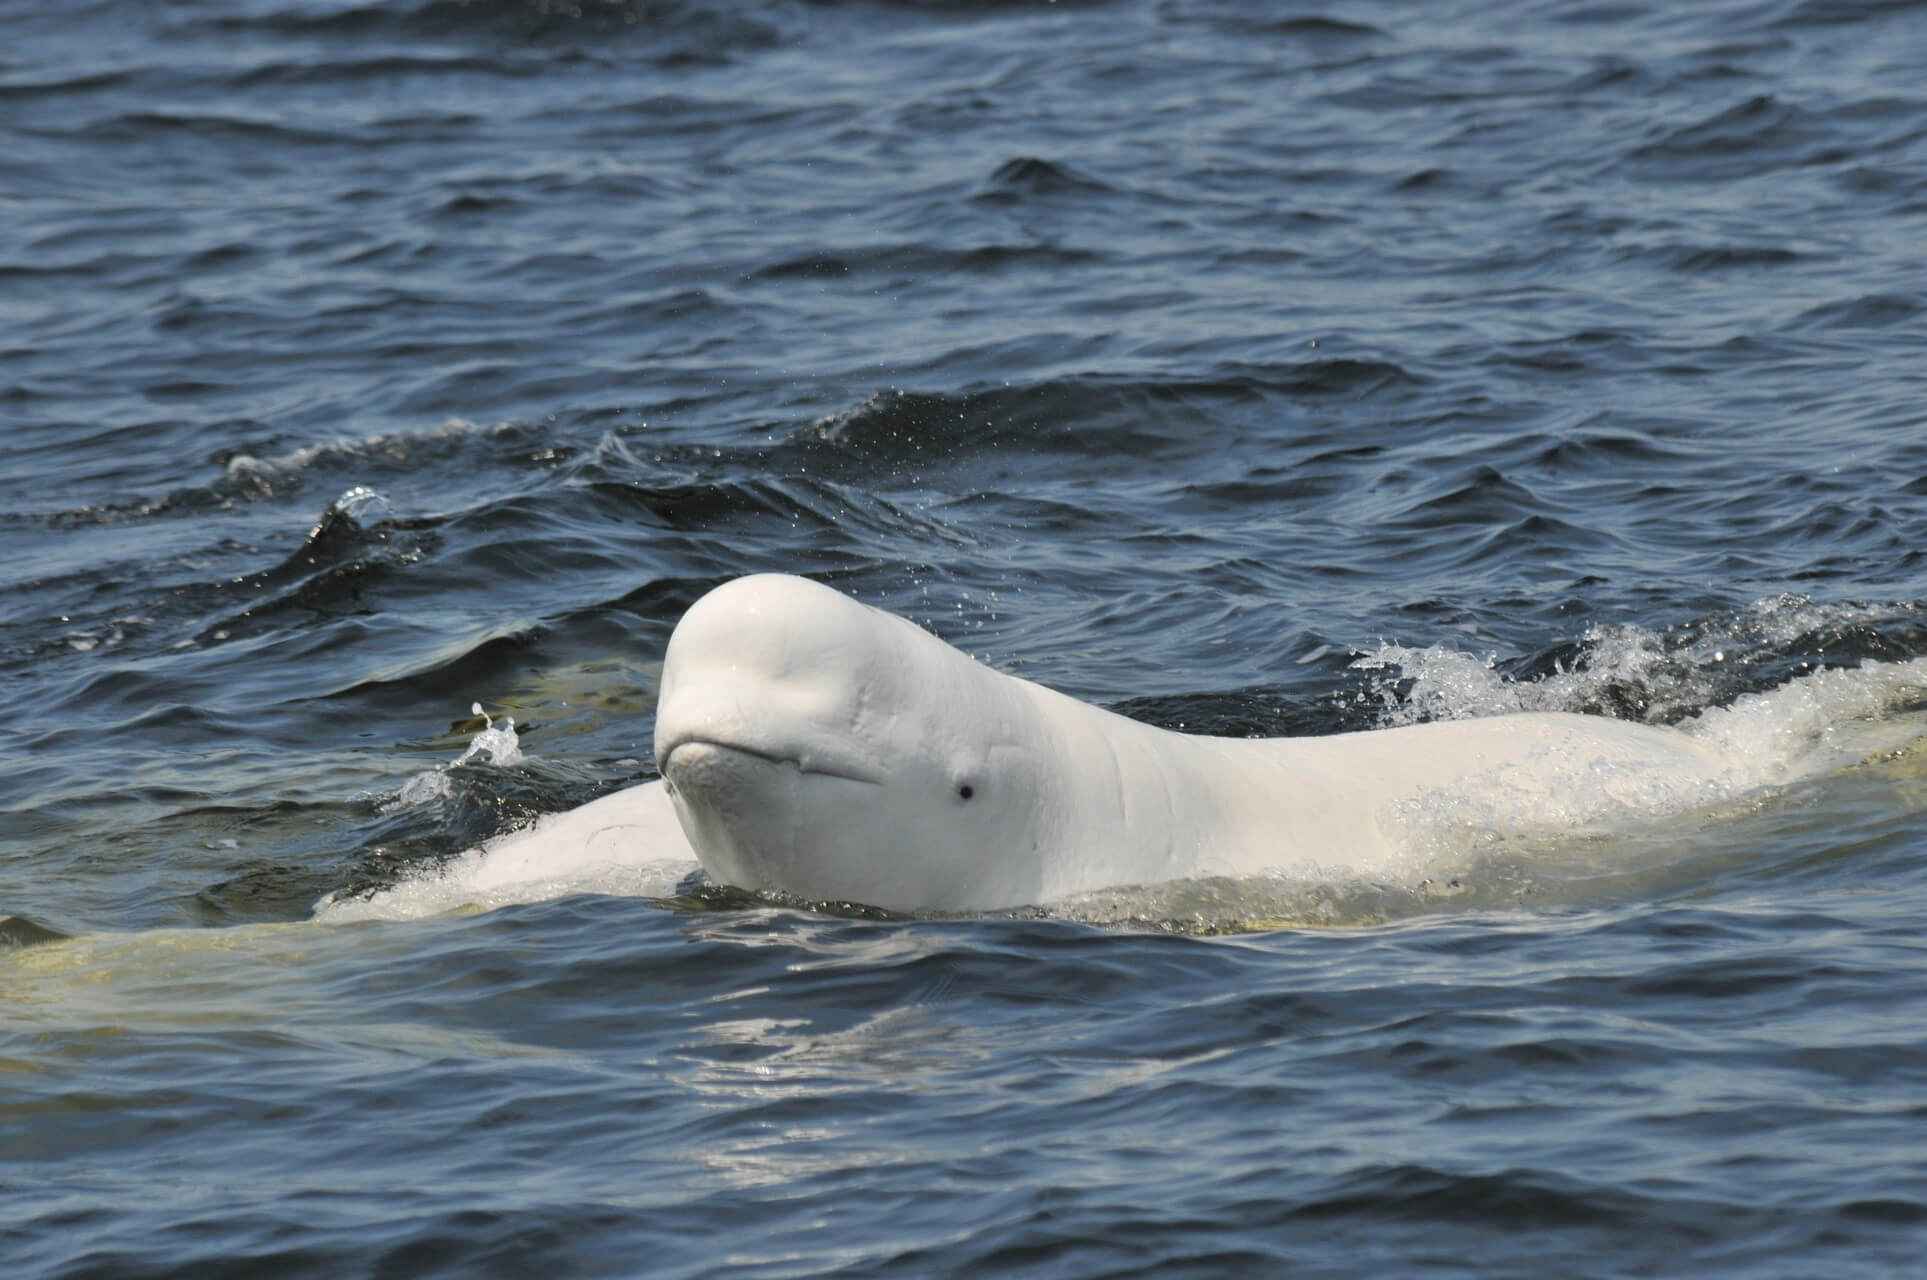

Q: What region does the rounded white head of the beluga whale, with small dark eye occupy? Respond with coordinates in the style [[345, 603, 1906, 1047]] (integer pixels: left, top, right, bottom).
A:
[[655, 574, 1054, 910]]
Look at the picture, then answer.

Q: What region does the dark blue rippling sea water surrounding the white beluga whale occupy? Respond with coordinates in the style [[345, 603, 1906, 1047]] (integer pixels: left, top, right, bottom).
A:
[[11, 0, 1927, 1278]]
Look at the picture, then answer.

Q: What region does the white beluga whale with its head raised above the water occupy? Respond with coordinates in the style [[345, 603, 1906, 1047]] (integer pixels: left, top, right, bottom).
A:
[[649, 574, 1757, 912]]
